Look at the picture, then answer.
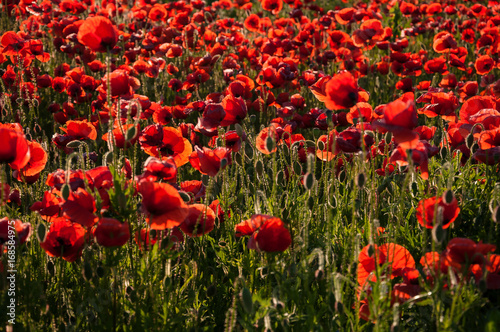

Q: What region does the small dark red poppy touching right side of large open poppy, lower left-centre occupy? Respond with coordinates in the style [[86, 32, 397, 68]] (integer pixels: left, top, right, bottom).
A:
[[179, 204, 215, 237]]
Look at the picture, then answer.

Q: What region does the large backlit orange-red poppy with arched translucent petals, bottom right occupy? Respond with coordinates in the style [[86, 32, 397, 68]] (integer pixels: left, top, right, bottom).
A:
[[357, 243, 415, 286]]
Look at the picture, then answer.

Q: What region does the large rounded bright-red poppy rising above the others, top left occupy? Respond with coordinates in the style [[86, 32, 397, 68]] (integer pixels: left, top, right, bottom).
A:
[[77, 16, 118, 52]]
